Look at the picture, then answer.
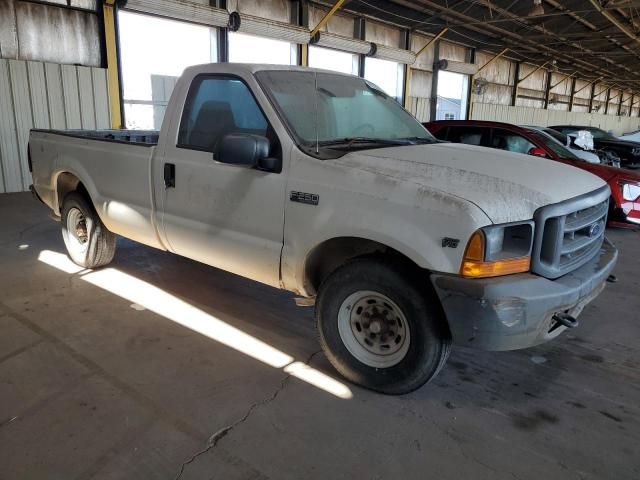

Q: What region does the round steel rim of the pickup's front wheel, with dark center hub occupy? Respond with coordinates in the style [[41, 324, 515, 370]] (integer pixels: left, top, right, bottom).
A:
[[338, 290, 411, 368]]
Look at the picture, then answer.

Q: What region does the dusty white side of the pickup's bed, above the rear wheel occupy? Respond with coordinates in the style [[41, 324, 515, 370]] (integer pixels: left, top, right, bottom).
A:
[[29, 125, 161, 247]]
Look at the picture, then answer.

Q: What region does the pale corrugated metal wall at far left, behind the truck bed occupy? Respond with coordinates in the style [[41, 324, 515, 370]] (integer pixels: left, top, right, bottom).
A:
[[0, 60, 110, 193]]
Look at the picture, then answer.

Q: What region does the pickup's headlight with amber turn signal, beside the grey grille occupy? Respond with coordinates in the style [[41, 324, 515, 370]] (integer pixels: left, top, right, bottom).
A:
[[460, 222, 534, 278]]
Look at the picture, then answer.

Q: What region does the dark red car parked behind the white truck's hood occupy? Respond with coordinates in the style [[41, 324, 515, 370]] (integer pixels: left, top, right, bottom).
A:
[[423, 120, 640, 227]]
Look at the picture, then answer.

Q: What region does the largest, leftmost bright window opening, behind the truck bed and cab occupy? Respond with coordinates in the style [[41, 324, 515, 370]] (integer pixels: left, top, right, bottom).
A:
[[118, 11, 217, 130]]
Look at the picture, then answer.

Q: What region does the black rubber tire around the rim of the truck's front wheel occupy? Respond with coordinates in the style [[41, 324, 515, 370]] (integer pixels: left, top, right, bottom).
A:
[[316, 258, 451, 395]]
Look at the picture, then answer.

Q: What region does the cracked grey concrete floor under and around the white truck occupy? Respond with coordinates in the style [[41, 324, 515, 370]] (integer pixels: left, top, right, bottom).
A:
[[0, 194, 640, 480]]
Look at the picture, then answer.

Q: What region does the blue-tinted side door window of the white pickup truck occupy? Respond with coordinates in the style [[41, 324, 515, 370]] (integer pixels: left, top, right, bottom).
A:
[[178, 76, 268, 152]]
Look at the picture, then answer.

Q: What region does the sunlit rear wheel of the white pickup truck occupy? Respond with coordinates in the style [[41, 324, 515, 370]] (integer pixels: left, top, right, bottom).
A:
[[61, 192, 116, 268]]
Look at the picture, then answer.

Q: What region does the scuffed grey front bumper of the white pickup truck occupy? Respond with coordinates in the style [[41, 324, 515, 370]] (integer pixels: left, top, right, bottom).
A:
[[431, 239, 618, 350]]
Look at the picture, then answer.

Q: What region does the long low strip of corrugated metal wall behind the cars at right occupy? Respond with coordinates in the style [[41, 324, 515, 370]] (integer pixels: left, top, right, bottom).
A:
[[472, 103, 640, 135]]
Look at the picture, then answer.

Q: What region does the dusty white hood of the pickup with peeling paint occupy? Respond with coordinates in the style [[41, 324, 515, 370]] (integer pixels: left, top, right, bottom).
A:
[[334, 143, 605, 223]]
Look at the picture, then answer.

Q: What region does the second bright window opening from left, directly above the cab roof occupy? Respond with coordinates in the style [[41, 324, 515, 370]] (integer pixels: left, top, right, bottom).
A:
[[229, 32, 298, 65]]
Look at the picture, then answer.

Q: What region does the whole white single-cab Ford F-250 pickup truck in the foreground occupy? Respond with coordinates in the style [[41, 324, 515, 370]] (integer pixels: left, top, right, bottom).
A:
[[29, 64, 617, 394]]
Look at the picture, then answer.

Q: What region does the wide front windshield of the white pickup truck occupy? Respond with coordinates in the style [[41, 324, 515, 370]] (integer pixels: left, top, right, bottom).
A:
[[256, 70, 436, 149]]
